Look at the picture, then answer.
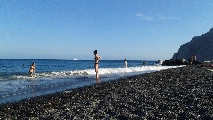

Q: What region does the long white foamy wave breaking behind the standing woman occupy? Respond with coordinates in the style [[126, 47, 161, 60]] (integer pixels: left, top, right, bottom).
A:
[[15, 66, 185, 79]]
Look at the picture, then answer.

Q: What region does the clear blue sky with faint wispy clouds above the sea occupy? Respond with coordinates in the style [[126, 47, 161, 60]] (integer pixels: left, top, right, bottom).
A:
[[0, 0, 213, 60]]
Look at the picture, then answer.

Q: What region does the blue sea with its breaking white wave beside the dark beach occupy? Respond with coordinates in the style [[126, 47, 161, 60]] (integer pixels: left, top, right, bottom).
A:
[[0, 59, 180, 104]]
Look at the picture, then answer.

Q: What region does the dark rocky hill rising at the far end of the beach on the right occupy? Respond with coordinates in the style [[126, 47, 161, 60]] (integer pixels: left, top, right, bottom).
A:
[[172, 28, 213, 61]]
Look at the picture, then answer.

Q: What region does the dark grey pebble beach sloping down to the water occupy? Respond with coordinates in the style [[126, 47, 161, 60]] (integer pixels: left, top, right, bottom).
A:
[[0, 66, 213, 120]]
